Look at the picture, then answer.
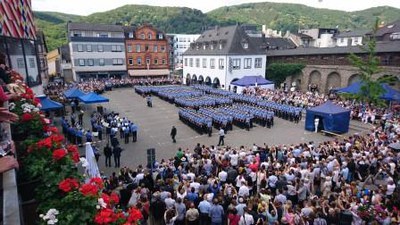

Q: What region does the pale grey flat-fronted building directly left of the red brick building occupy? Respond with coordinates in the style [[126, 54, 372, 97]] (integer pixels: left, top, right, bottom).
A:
[[68, 23, 127, 81]]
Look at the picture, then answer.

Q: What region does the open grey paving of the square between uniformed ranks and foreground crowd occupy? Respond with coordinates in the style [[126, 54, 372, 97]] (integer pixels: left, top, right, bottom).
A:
[[78, 88, 372, 175]]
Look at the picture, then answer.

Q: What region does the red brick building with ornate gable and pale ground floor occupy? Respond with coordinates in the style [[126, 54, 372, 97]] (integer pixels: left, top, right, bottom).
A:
[[125, 25, 169, 77]]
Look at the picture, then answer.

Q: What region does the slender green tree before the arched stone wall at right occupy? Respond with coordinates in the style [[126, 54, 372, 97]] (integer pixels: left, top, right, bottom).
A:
[[349, 19, 385, 105]]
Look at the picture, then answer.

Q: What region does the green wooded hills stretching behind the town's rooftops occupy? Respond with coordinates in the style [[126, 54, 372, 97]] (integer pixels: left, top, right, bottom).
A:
[[35, 2, 400, 50]]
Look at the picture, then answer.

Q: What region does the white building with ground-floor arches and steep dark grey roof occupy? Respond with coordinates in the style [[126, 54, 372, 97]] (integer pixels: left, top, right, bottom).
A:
[[183, 25, 267, 90]]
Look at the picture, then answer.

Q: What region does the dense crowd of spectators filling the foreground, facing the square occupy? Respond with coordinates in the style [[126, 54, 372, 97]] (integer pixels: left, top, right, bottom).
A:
[[98, 116, 400, 225]]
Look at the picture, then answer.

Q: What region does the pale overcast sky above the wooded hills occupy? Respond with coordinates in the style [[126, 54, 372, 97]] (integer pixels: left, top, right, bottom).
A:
[[32, 0, 400, 15]]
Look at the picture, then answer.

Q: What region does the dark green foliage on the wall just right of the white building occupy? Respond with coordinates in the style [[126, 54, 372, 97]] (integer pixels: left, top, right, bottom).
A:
[[267, 63, 305, 85]]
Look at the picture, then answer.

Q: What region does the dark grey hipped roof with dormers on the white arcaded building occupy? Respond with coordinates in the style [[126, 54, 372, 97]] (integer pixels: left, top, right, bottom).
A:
[[184, 25, 266, 55]]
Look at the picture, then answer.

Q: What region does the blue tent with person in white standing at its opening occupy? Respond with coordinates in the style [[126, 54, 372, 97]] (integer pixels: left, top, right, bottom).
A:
[[305, 101, 350, 134]]
